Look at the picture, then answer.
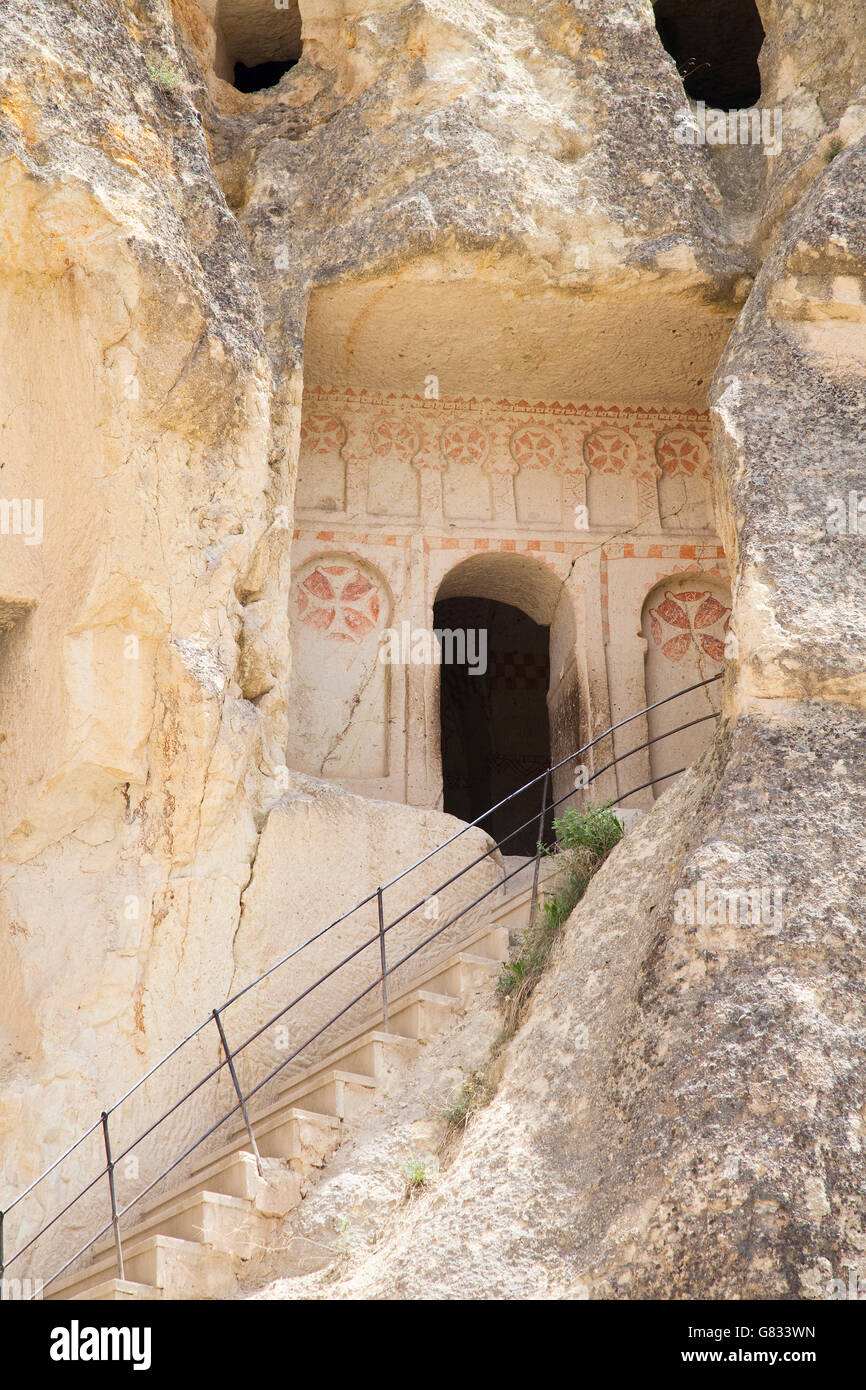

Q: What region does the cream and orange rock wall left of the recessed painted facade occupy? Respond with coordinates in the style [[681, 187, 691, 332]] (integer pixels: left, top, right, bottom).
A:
[[0, 4, 279, 1217]]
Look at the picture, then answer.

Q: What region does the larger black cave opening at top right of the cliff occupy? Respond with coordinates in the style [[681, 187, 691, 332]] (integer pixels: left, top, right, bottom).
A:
[[653, 0, 765, 111]]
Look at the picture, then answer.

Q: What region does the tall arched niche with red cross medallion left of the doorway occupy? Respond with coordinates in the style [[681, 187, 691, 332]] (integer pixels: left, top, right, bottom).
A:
[[286, 553, 392, 783]]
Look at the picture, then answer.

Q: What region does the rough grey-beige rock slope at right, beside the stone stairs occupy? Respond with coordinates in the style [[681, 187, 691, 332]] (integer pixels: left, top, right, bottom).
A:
[[296, 702, 866, 1298]]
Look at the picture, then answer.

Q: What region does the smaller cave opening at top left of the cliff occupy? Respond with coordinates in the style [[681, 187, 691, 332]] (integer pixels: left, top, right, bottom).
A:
[[215, 0, 302, 92]]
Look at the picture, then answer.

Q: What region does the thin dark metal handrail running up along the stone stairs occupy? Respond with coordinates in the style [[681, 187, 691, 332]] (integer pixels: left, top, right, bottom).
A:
[[0, 673, 724, 1298]]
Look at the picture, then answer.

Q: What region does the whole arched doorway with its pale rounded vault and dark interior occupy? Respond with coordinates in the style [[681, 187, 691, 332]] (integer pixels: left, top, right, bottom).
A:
[[434, 555, 578, 855]]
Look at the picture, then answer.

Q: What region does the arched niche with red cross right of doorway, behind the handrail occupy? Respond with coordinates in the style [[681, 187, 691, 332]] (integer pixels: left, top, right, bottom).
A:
[[642, 573, 731, 795]]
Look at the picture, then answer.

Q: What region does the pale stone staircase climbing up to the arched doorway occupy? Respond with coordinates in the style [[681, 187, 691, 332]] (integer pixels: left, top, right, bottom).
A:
[[46, 860, 558, 1301]]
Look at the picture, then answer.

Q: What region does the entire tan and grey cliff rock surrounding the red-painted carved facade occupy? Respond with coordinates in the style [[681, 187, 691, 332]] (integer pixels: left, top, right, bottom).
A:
[[0, 0, 866, 1298]]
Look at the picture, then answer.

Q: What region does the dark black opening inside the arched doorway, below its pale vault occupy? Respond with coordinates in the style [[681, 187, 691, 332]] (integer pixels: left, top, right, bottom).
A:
[[434, 598, 552, 855]]
